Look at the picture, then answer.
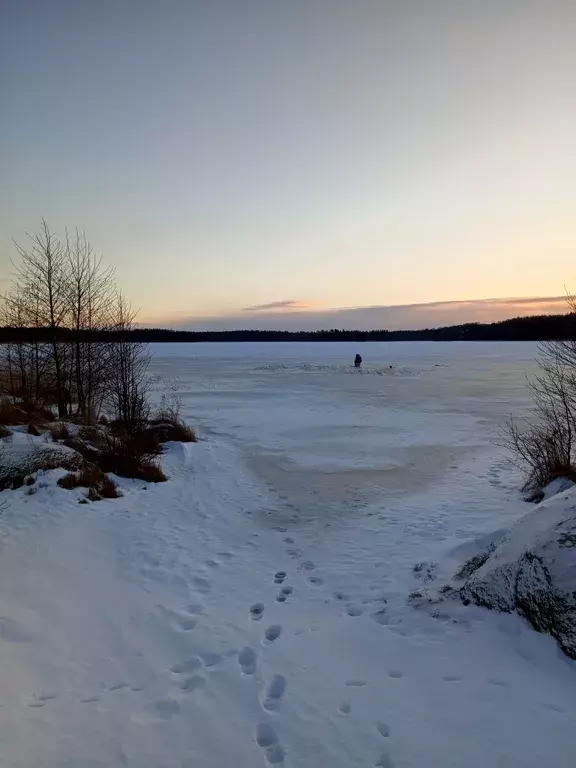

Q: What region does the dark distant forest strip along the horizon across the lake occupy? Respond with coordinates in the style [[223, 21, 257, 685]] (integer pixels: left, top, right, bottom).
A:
[[0, 313, 576, 343]]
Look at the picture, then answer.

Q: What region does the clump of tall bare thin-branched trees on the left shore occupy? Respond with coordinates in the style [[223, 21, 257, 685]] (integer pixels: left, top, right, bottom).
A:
[[0, 221, 150, 434]]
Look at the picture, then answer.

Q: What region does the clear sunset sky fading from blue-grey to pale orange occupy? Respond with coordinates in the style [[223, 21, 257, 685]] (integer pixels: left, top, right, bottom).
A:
[[0, 0, 576, 328]]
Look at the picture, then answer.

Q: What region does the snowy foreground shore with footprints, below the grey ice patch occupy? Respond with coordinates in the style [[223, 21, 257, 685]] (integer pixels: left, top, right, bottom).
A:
[[0, 440, 576, 768]]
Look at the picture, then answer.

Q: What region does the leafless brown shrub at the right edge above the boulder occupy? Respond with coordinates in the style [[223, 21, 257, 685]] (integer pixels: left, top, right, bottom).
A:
[[500, 296, 576, 500]]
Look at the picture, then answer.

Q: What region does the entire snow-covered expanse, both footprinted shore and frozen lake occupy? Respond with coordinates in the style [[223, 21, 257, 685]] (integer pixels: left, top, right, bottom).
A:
[[0, 344, 576, 768]]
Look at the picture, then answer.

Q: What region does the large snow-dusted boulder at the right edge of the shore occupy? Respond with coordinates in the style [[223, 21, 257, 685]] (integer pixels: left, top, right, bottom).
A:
[[460, 489, 576, 658]]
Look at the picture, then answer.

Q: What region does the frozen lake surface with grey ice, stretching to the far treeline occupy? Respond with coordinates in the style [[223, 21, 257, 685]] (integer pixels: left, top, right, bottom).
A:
[[152, 343, 537, 512]]
